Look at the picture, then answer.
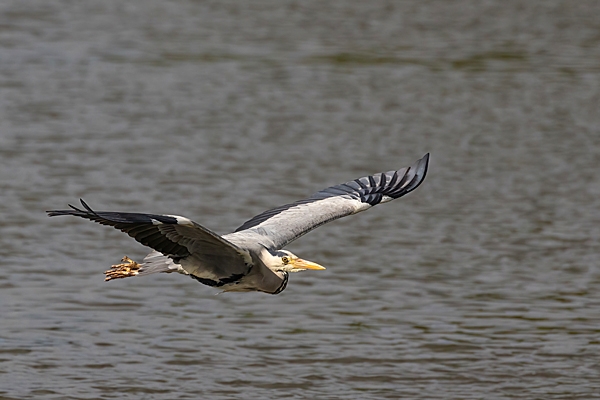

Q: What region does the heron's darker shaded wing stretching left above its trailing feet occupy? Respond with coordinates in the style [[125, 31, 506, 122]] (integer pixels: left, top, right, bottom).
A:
[[47, 200, 251, 281]]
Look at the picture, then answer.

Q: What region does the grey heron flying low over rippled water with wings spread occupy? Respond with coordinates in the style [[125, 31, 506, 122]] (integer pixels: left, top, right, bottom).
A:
[[47, 153, 429, 294]]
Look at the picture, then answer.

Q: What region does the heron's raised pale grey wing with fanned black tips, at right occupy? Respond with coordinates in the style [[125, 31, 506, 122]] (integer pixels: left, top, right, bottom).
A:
[[226, 153, 429, 249]]
